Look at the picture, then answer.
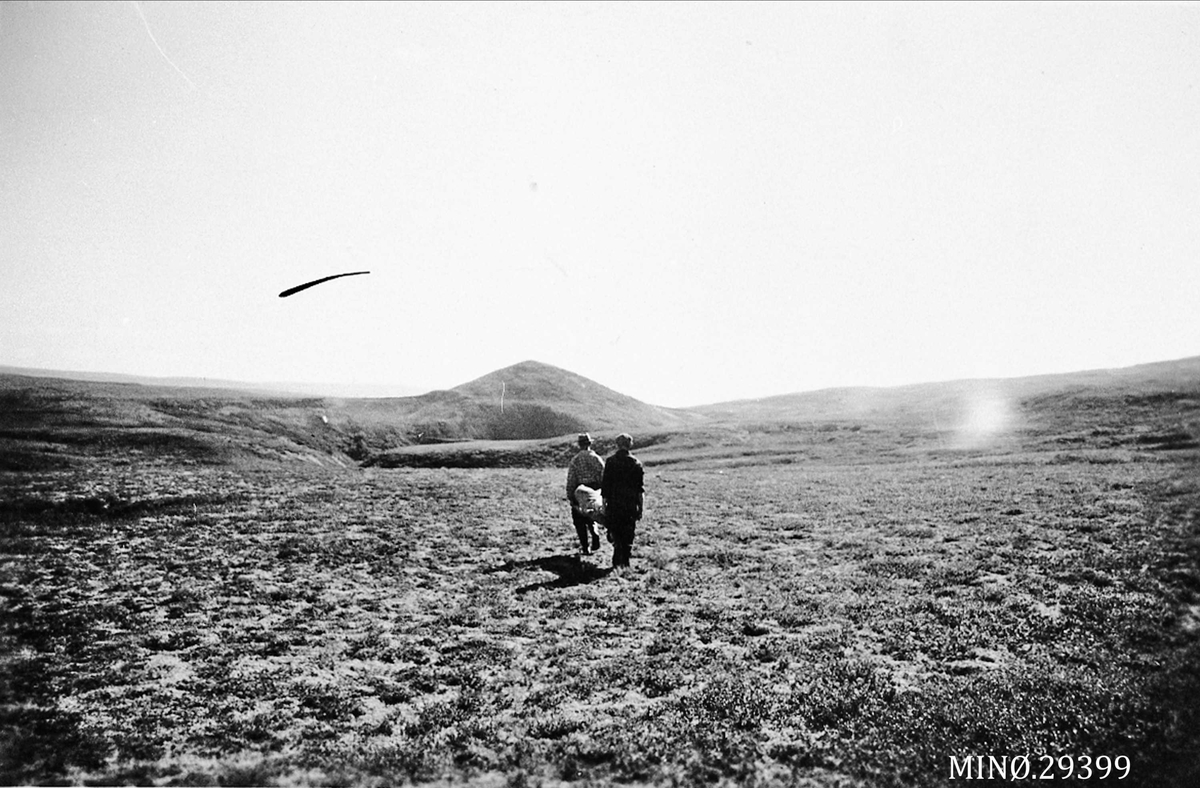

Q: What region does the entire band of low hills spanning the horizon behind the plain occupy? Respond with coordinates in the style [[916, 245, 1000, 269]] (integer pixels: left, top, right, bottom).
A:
[[0, 357, 1200, 470]]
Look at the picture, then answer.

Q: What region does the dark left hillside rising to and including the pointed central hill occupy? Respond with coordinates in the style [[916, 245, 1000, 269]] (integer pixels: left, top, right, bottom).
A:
[[0, 362, 701, 470]]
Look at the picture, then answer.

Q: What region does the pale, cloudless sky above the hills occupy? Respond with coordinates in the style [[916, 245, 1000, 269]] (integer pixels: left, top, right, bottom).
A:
[[0, 1, 1200, 405]]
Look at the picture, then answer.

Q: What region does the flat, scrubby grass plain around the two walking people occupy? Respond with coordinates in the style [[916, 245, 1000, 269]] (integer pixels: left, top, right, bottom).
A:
[[0, 371, 1200, 787]]
